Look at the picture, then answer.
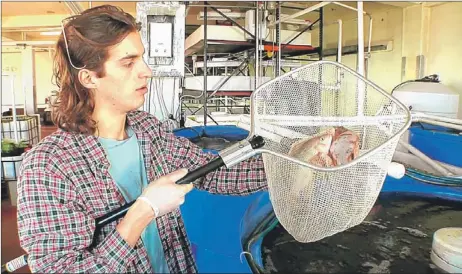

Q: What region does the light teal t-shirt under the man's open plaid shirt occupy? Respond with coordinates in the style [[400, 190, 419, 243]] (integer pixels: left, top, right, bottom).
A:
[[99, 128, 169, 273]]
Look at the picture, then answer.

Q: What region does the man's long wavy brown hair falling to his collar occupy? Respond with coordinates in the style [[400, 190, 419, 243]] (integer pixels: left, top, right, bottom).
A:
[[52, 5, 140, 134]]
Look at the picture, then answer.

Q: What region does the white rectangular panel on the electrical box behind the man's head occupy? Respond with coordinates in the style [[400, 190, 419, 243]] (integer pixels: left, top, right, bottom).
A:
[[149, 22, 173, 57]]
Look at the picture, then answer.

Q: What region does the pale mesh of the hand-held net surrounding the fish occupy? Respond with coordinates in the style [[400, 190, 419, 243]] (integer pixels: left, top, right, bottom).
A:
[[252, 61, 409, 242]]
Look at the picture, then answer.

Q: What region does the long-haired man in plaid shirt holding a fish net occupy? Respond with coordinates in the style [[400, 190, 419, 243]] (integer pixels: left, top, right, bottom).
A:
[[18, 6, 267, 273]]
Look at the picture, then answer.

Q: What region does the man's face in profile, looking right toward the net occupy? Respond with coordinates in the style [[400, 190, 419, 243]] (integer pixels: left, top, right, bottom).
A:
[[95, 32, 152, 113]]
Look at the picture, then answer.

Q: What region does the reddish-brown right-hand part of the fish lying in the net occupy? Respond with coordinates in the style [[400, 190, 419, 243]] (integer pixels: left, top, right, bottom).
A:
[[329, 127, 359, 166]]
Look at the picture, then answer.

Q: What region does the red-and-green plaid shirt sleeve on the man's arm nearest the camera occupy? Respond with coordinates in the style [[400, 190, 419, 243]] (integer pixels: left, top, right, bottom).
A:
[[18, 150, 136, 273]]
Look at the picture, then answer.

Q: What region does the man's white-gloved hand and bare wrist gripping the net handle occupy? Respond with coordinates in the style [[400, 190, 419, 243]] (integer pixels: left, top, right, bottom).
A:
[[116, 169, 193, 247]]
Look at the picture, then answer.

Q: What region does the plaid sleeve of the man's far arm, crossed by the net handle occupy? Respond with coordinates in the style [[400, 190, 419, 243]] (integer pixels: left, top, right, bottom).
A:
[[158, 122, 267, 195]]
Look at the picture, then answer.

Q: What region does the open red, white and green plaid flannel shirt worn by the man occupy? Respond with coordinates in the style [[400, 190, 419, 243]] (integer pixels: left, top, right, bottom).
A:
[[18, 111, 267, 273]]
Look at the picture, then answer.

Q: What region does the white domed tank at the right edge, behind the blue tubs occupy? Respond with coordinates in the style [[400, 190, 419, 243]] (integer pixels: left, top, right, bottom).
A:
[[393, 82, 459, 118]]
